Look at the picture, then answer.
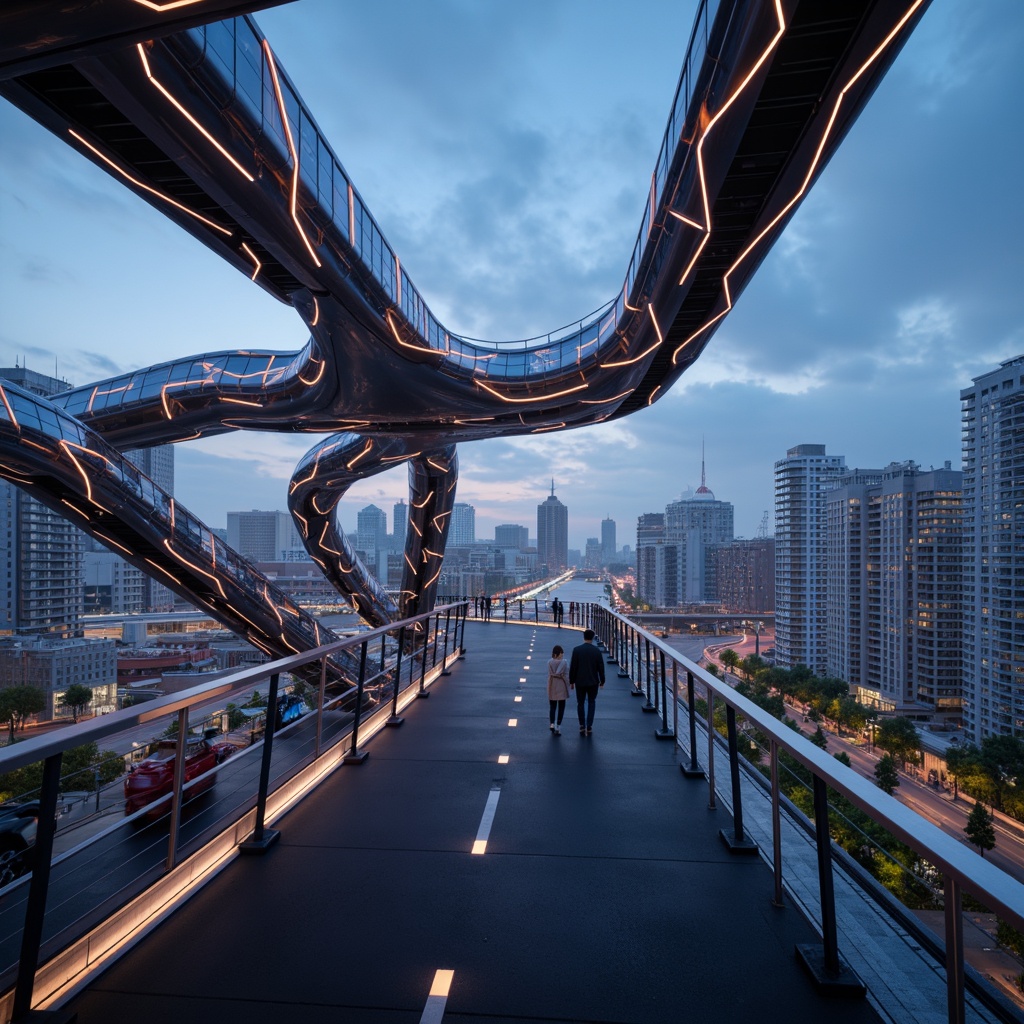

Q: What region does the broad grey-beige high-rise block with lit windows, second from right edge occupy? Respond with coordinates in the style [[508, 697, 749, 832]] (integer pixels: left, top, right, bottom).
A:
[[825, 462, 963, 725]]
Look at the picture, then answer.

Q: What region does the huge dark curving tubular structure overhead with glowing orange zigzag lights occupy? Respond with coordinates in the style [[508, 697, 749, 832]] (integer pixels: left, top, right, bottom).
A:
[[0, 0, 928, 654]]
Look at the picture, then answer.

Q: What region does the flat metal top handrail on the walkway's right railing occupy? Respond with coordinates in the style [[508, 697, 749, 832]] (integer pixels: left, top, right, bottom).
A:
[[599, 605, 1024, 930]]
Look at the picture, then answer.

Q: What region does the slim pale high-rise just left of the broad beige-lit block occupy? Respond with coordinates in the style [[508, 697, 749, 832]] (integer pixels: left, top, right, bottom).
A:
[[775, 444, 846, 675]]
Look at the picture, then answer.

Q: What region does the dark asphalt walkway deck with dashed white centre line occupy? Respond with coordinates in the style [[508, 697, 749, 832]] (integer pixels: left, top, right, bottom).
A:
[[66, 624, 879, 1024]]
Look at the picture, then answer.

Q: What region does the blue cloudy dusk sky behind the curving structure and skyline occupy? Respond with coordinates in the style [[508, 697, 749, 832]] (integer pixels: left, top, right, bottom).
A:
[[0, 0, 1024, 547]]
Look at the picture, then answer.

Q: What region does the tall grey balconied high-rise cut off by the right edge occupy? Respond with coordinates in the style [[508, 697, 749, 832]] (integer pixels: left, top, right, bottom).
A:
[[961, 355, 1024, 742]]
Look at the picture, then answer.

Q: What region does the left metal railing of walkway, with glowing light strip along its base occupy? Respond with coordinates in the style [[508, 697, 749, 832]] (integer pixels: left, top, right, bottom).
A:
[[0, 603, 467, 1022]]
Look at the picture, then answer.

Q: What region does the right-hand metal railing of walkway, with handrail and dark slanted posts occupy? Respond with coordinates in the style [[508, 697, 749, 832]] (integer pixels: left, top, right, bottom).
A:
[[587, 605, 1024, 1024]]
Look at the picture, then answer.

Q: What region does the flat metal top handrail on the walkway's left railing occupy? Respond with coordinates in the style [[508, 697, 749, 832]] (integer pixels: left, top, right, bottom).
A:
[[0, 601, 463, 774]]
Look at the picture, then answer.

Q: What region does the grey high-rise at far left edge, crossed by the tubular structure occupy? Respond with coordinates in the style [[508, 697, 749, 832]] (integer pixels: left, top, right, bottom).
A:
[[0, 367, 85, 637]]
